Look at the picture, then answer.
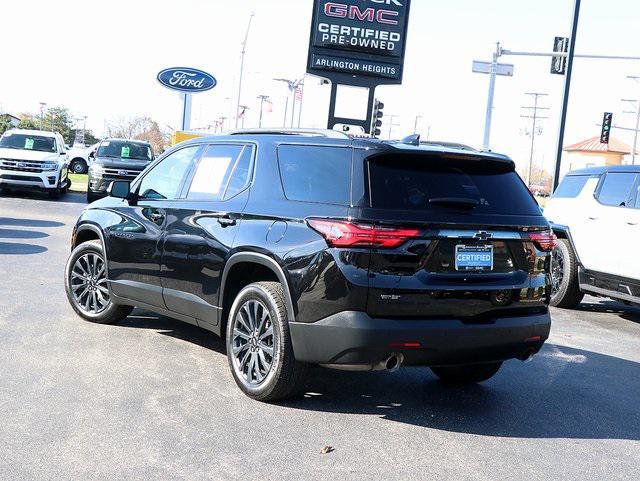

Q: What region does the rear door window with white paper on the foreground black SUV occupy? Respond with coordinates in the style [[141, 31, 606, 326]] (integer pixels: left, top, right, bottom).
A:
[[187, 145, 252, 201]]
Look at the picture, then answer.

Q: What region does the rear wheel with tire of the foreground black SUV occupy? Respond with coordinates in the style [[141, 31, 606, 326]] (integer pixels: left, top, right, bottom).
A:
[[226, 282, 305, 401]]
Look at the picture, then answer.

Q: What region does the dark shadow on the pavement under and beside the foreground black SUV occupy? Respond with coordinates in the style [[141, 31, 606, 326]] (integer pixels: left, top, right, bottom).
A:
[[120, 313, 640, 440]]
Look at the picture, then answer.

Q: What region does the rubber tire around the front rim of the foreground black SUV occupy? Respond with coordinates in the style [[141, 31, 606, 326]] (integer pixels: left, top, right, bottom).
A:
[[64, 240, 133, 324]]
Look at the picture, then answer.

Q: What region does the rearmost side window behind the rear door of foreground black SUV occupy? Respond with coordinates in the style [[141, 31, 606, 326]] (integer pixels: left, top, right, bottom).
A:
[[278, 145, 351, 205]]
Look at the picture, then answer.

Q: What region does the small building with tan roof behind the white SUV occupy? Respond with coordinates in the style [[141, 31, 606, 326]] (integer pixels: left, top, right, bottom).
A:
[[563, 137, 631, 174]]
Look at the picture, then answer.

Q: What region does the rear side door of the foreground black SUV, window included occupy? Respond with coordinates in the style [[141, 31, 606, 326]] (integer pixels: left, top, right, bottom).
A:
[[162, 144, 255, 327]]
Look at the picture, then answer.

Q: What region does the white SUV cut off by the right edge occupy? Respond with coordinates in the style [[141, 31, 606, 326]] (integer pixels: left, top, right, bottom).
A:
[[544, 166, 640, 308]]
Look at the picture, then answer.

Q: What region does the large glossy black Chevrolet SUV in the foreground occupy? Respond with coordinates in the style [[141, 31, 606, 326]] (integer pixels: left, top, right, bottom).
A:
[[65, 131, 555, 400]]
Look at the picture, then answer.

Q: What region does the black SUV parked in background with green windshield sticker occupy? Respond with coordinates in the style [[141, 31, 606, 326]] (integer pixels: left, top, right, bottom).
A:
[[87, 139, 154, 203]]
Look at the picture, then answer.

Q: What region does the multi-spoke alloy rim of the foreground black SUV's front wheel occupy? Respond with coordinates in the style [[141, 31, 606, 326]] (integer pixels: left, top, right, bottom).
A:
[[69, 252, 111, 315]]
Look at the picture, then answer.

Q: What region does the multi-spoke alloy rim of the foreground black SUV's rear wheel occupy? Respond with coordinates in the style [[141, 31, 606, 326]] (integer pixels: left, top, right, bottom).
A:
[[230, 299, 277, 387]]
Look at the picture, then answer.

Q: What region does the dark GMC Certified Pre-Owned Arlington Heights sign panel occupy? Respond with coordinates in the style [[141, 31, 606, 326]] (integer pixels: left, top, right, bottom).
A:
[[307, 0, 410, 85]]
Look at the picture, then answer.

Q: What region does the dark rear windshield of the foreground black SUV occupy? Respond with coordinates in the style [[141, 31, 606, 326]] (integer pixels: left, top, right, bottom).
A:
[[369, 157, 541, 215]]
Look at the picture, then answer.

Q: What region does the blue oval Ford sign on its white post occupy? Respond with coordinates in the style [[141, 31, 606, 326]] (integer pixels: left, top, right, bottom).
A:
[[157, 67, 218, 132]]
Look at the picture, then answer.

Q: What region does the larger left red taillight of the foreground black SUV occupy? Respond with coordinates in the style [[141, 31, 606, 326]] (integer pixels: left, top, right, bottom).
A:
[[308, 219, 420, 248]]
